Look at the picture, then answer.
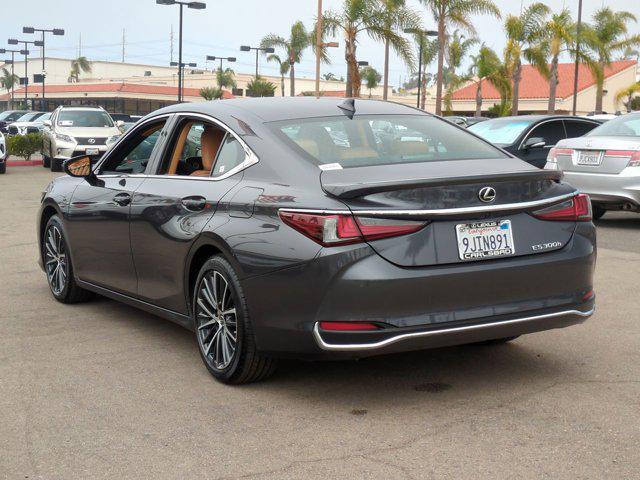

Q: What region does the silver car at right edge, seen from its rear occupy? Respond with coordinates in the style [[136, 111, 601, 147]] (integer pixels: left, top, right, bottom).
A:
[[545, 113, 640, 219]]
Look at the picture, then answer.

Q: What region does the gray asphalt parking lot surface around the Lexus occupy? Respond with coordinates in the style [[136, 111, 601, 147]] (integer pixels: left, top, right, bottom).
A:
[[0, 167, 640, 479]]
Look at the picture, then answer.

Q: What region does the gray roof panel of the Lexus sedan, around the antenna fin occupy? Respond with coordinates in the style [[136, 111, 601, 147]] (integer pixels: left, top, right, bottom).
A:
[[154, 97, 429, 122]]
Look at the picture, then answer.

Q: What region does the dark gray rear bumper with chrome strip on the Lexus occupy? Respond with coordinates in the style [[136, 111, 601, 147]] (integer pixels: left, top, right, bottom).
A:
[[242, 222, 596, 358]]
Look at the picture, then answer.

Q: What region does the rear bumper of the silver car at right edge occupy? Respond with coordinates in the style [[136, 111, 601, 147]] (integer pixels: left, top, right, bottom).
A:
[[564, 167, 640, 209]]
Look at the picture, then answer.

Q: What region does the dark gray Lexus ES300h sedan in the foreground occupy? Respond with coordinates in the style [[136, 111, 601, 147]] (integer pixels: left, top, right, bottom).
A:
[[37, 97, 596, 383]]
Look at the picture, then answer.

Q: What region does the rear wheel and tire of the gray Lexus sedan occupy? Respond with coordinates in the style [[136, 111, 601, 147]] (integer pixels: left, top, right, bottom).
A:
[[192, 255, 277, 385]]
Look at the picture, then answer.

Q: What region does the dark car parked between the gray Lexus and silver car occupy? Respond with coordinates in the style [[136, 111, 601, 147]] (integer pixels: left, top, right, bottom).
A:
[[469, 115, 601, 168]]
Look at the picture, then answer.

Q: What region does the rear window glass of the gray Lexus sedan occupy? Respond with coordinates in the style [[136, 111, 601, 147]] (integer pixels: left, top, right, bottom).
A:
[[272, 115, 505, 168]]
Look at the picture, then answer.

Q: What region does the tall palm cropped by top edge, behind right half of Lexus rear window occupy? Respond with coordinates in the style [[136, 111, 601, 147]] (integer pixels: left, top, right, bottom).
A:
[[420, 0, 500, 115]]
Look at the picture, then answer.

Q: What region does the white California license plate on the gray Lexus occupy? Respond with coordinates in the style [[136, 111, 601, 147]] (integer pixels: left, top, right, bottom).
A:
[[456, 220, 516, 260]]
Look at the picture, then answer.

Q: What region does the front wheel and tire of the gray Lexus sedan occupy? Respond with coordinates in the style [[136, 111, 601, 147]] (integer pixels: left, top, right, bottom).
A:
[[42, 215, 91, 303]]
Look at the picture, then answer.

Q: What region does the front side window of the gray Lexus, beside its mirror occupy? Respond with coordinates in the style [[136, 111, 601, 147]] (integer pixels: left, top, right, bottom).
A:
[[100, 122, 165, 174]]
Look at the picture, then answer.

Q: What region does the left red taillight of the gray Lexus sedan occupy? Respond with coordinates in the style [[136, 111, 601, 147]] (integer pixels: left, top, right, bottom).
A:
[[280, 211, 427, 247]]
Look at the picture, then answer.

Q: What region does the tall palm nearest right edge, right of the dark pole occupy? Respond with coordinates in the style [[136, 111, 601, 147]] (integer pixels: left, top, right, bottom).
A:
[[581, 7, 640, 112]]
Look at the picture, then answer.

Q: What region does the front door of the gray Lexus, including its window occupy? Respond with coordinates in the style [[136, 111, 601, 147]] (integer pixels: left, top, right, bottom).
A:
[[66, 117, 167, 295]]
